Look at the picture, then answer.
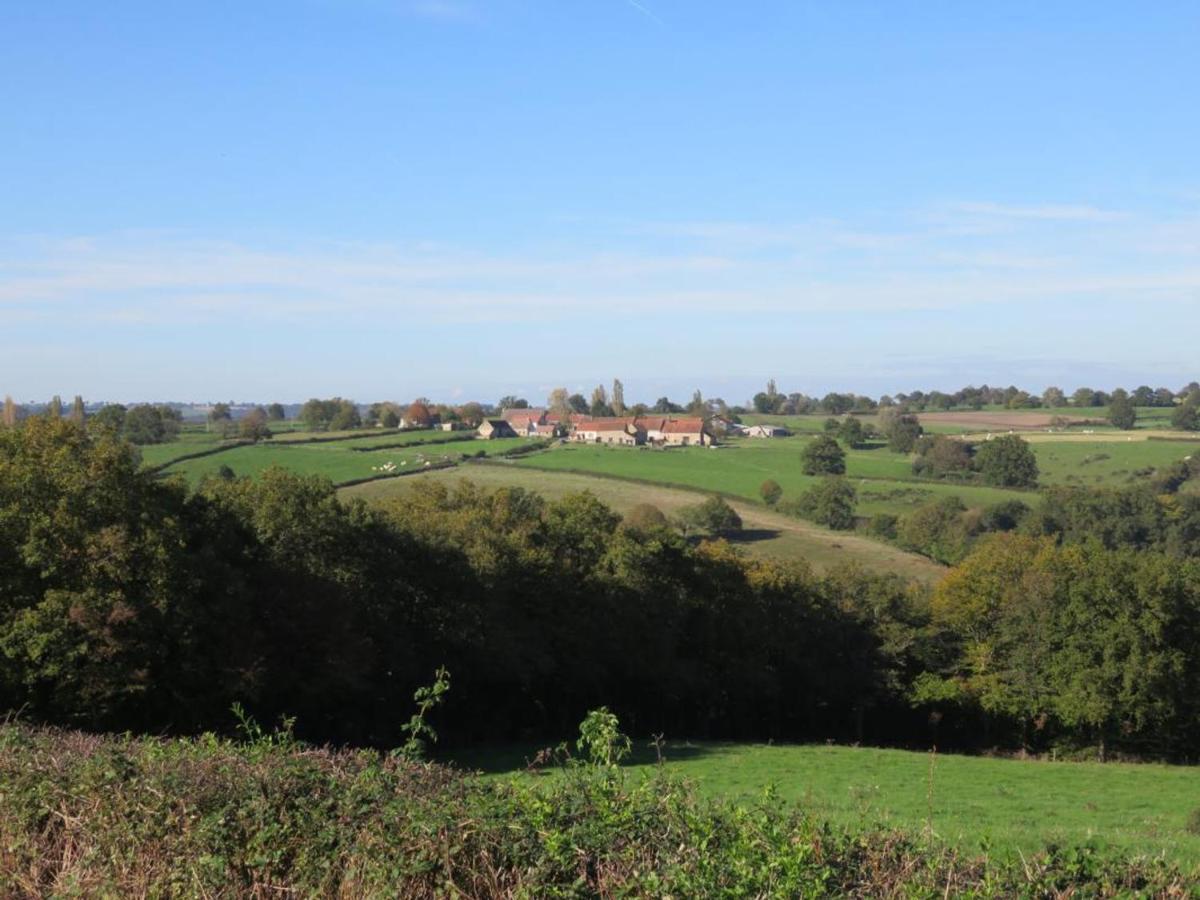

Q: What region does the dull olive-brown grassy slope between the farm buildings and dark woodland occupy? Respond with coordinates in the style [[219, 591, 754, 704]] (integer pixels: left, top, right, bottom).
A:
[[341, 463, 946, 582]]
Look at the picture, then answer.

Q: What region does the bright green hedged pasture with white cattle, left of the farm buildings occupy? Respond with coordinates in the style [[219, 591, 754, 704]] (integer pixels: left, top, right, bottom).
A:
[[156, 438, 528, 484]]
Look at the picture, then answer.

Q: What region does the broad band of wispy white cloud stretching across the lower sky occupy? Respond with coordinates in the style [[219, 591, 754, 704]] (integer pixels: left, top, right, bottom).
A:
[[0, 204, 1200, 336]]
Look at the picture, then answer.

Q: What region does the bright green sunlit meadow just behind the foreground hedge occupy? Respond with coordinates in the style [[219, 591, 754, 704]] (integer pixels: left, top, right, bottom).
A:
[[455, 742, 1200, 870]]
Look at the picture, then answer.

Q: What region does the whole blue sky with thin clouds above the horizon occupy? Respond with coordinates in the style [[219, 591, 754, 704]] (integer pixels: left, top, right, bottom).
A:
[[0, 0, 1200, 401]]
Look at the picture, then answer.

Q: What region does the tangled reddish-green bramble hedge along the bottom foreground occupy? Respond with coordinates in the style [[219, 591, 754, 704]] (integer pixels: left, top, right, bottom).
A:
[[0, 724, 1192, 898]]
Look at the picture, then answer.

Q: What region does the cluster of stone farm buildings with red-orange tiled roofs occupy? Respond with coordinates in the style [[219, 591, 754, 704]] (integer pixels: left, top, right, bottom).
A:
[[479, 408, 719, 446]]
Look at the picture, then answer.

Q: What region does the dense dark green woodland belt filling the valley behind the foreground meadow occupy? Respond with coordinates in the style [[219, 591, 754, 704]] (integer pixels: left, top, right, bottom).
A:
[[0, 416, 1200, 758]]
